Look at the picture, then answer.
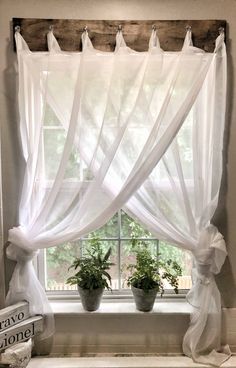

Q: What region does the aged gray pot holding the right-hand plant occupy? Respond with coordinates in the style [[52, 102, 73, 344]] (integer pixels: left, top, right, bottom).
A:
[[131, 286, 157, 312]]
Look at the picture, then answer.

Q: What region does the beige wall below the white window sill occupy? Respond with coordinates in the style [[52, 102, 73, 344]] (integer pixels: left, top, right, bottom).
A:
[[48, 301, 236, 356]]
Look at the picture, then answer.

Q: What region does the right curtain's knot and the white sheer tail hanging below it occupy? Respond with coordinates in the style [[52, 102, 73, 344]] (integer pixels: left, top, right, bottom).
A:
[[183, 225, 230, 366]]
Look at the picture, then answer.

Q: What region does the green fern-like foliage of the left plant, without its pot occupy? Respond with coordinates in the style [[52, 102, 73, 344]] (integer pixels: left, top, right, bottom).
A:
[[66, 238, 113, 290]]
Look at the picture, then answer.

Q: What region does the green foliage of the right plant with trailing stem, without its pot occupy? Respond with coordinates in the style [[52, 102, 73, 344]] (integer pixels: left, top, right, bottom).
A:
[[127, 233, 182, 296]]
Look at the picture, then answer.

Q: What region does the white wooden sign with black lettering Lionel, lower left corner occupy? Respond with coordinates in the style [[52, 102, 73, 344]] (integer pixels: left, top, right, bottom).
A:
[[0, 316, 43, 352]]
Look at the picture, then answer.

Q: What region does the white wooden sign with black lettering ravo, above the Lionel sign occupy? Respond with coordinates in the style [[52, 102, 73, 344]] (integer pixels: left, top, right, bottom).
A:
[[0, 302, 29, 332]]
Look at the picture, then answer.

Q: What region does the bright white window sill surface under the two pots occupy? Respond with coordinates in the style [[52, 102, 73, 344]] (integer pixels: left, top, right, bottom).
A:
[[51, 299, 192, 316]]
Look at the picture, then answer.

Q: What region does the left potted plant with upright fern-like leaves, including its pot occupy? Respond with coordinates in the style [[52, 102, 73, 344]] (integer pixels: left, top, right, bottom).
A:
[[67, 238, 113, 311]]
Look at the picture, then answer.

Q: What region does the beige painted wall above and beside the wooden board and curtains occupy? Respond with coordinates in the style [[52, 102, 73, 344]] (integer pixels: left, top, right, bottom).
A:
[[0, 0, 236, 307]]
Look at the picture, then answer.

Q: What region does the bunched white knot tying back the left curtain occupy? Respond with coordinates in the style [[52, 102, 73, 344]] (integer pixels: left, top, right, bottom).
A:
[[6, 226, 38, 263]]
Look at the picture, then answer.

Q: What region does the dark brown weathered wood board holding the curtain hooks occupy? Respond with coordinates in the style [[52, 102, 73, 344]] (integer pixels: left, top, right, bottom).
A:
[[12, 18, 226, 52]]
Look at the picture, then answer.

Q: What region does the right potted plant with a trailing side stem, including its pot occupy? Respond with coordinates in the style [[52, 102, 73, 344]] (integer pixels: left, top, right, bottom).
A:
[[127, 236, 182, 312]]
